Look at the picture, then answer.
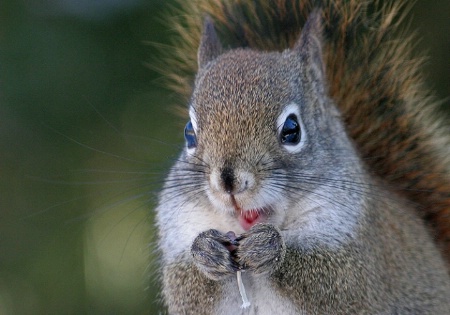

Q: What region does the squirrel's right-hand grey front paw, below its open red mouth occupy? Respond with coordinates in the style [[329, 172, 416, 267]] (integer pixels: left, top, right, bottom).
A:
[[235, 224, 286, 274]]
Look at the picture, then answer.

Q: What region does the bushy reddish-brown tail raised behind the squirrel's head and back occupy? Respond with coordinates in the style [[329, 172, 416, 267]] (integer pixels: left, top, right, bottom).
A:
[[166, 0, 450, 262]]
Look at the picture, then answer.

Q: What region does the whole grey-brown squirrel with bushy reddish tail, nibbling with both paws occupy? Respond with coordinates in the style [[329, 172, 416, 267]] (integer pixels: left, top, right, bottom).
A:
[[156, 0, 450, 314]]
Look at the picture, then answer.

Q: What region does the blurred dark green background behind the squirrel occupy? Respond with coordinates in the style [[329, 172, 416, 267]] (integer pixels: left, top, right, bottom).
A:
[[0, 0, 450, 315]]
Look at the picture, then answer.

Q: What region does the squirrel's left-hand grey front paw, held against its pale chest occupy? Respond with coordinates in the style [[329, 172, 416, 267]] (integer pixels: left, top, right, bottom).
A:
[[191, 229, 239, 280]]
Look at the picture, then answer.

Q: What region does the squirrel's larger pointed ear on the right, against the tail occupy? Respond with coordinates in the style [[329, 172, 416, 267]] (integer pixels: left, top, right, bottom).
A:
[[293, 9, 325, 82]]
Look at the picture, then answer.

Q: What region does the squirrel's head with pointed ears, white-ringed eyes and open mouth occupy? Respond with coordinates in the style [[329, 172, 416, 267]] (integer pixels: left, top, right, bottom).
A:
[[185, 11, 356, 229]]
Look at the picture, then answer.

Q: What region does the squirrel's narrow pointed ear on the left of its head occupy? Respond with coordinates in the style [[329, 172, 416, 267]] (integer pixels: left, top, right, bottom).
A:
[[197, 16, 222, 69]]
